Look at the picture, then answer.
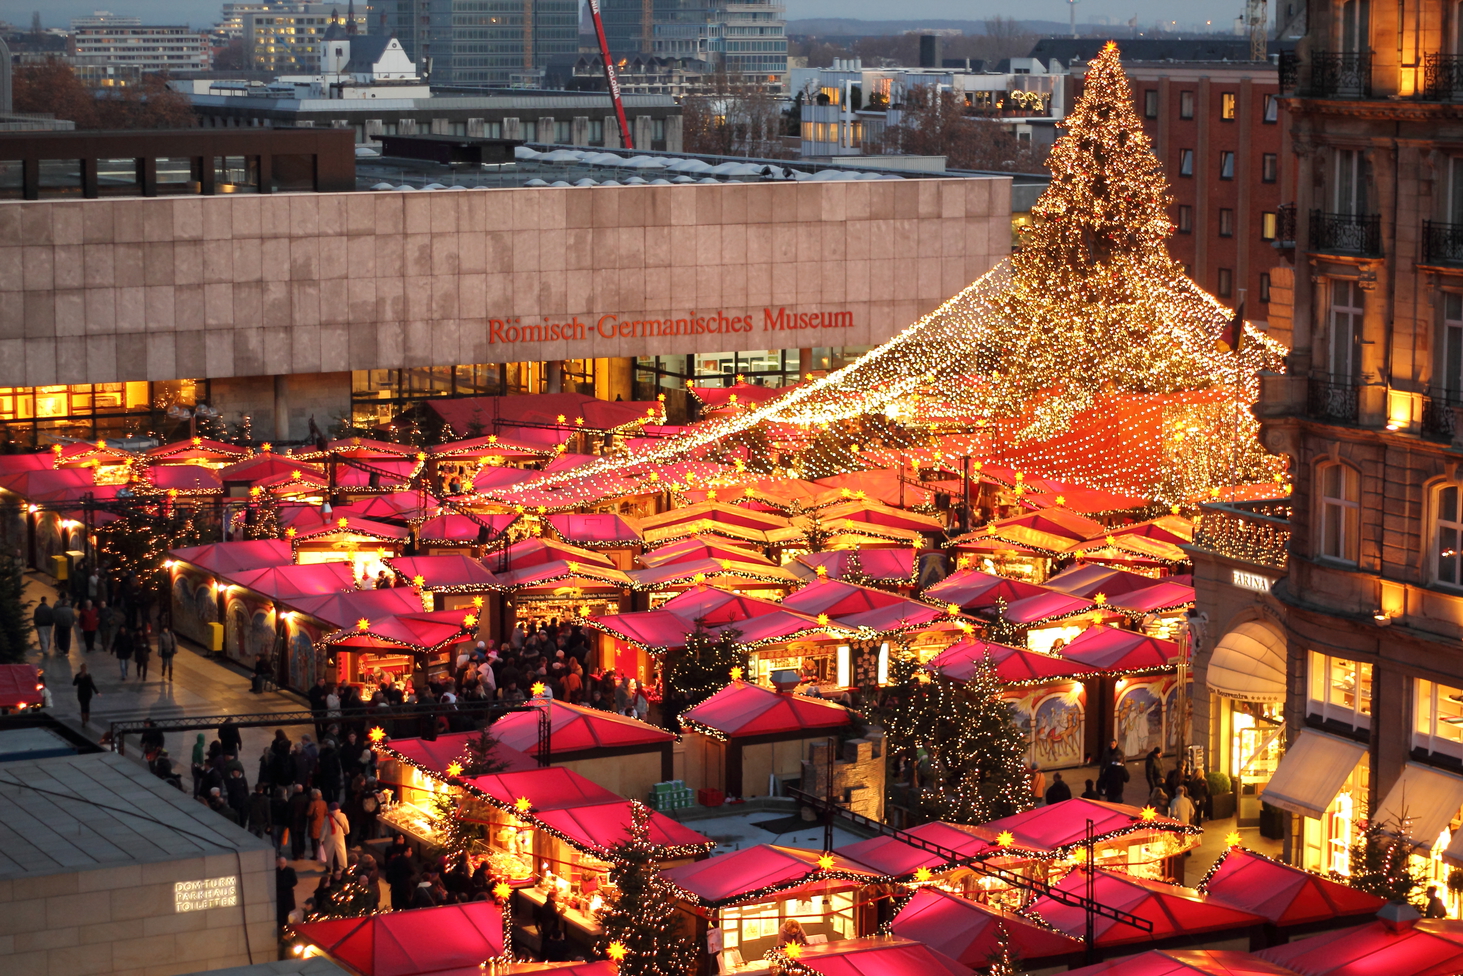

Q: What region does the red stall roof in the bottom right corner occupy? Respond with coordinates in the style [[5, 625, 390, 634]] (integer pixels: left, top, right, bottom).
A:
[[1255, 919, 1463, 976]]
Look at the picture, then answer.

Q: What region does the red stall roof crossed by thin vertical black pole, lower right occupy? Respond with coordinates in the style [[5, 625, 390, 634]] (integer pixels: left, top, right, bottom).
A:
[[1027, 872, 1264, 945]]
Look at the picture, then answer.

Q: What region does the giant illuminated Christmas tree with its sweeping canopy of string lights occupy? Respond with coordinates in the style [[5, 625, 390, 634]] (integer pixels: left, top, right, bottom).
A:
[[479, 45, 1285, 508]]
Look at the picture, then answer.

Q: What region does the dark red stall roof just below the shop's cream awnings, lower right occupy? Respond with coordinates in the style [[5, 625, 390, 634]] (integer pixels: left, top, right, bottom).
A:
[[1201, 847, 1385, 925]]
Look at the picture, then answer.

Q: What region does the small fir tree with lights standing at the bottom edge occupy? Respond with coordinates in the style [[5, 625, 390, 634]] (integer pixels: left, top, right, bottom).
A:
[[595, 800, 696, 976]]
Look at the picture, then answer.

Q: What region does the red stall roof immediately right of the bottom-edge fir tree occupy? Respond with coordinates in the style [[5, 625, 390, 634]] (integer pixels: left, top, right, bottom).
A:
[[661, 844, 885, 909]]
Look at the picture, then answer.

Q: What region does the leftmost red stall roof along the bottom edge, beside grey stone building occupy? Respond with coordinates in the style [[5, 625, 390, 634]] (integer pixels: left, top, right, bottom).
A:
[[294, 901, 512, 976]]
